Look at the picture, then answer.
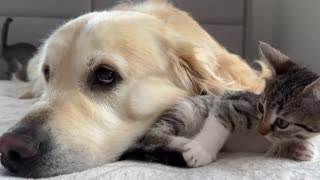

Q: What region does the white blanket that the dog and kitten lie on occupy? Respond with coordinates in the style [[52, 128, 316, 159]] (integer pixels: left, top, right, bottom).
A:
[[0, 81, 320, 180]]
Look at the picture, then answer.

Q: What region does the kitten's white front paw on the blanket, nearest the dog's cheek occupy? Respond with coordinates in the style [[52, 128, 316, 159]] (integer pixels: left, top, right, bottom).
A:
[[182, 141, 216, 167]]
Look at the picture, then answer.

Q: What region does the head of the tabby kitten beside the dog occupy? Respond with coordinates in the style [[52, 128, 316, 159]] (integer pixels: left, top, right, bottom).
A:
[[258, 43, 320, 141]]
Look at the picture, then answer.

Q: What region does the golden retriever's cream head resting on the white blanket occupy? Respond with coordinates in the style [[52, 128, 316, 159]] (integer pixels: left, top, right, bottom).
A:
[[0, 11, 220, 177]]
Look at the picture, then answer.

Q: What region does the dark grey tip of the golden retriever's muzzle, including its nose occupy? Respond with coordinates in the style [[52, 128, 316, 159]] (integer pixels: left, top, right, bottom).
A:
[[0, 108, 50, 176]]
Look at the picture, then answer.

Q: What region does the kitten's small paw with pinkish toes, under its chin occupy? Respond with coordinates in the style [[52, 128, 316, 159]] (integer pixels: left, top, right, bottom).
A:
[[289, 142, 317, 161]]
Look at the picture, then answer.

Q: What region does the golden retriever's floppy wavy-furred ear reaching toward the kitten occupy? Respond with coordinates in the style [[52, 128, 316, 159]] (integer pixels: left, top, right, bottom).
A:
[[162, 31, 271, 95]]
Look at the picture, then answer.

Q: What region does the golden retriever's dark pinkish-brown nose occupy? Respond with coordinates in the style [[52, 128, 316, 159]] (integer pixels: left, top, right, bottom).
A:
[[0, 132, 39, 171]]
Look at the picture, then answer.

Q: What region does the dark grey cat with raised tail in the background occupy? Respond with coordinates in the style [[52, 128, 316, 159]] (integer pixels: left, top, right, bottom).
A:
[[1, 18, 37, 81]]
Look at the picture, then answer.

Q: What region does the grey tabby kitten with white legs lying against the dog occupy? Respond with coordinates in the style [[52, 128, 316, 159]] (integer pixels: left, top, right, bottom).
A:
[[122, 43, 320, 167]]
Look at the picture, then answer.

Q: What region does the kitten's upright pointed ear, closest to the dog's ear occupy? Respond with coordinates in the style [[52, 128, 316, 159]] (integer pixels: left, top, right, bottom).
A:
[[259, 41, 295, 74]]
